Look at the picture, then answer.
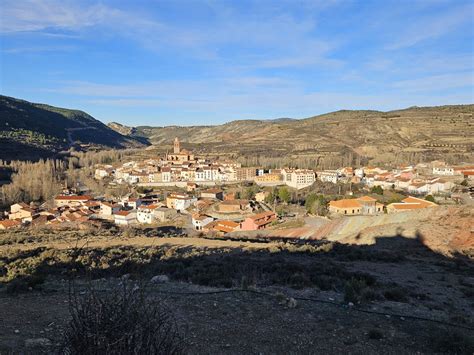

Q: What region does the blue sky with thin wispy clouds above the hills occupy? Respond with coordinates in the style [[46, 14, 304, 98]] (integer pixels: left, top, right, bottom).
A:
[[0, 0, 474, 126]]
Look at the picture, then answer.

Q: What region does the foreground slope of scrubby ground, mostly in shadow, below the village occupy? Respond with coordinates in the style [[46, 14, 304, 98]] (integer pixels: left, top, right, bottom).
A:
[[0, 211, 474, 354]]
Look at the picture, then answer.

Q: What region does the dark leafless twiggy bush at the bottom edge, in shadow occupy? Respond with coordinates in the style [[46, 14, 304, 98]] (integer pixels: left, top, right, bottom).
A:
[[63, 284, 184, 354]]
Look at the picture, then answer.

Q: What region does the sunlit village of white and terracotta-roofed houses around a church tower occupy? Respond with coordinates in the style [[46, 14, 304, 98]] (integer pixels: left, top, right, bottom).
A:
[[0, 138, 474, 236]]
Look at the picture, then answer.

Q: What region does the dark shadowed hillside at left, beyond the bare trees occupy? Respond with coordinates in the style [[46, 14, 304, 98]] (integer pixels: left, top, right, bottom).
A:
[[0, 96, 143, 160]]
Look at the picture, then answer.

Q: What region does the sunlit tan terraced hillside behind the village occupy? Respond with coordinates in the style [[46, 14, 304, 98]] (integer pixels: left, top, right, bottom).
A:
[[112, 105, 474, 167]]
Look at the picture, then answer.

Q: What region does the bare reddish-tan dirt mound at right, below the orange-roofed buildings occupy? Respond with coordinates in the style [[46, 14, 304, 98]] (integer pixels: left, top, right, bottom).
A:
[[268, 206, 474, 254]]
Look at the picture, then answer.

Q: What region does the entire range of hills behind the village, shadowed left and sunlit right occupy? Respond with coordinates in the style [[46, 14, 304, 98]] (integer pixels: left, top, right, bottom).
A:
[[0, 96, 474, 167]]
